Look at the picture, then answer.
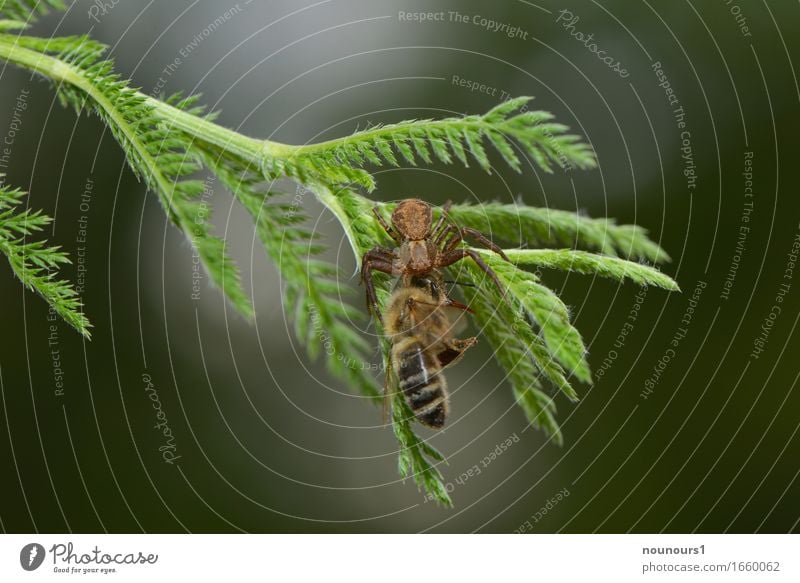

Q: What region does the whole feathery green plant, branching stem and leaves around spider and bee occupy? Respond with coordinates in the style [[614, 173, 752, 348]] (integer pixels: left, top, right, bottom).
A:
[[0, 25, 677, 504]]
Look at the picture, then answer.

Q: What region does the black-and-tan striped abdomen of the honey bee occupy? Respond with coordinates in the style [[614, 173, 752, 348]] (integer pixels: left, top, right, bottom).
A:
[[392, 338, 447, 429]]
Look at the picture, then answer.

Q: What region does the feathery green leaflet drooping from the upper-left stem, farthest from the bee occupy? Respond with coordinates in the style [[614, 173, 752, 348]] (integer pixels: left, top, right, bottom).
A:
[[7, 36, 252, 316]]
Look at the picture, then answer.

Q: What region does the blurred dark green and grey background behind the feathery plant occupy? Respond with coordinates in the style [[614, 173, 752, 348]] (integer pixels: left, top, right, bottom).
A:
[[0, 0, 800, 532]]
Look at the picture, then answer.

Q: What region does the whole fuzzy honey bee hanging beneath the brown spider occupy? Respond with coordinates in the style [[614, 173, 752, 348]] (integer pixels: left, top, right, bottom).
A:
[[384, 272, 477, 429]]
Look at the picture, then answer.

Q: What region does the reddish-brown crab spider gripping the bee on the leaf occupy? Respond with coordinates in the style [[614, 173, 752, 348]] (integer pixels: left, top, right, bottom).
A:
[[361, 198, 508, 323]]
